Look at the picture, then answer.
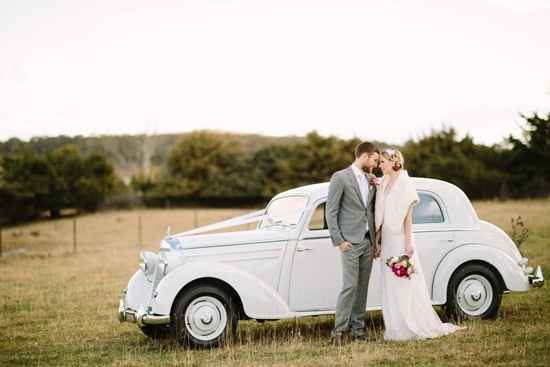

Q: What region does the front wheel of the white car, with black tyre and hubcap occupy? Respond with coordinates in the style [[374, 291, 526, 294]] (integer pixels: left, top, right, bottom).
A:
[[171, 285, 239, 347]]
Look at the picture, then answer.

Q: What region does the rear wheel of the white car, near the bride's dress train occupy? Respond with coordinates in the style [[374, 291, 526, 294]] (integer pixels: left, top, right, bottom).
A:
[[445, 263, 503, 320]]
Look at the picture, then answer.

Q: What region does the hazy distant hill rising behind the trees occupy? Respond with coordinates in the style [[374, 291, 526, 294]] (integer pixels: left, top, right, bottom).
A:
[[0, 131, 305, 183]]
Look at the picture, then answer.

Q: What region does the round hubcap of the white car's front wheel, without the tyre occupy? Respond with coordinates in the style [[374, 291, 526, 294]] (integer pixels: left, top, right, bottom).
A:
[[185, 296, 227, 341]]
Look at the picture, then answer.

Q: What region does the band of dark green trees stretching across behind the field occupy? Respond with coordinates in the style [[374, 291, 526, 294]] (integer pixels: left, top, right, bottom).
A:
[[0, 113, 550, 221]]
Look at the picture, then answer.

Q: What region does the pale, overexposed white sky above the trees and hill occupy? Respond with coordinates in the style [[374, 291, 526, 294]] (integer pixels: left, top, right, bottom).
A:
[[0, 0, 550, 144]]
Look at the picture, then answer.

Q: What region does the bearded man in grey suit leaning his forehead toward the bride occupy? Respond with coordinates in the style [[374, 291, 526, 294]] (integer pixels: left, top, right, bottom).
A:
[[326, 142, 379, 345]]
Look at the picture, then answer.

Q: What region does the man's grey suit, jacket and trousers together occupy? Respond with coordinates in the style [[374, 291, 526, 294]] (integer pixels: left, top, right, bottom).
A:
[[326, 167, 376, 336]]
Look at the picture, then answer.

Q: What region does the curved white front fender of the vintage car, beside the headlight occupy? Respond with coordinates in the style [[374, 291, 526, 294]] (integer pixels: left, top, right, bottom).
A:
[[151, 261, 291, 319]]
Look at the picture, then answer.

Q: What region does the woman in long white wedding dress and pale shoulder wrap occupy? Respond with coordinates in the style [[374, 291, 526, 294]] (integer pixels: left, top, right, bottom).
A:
[[375, 149, 462, 340]]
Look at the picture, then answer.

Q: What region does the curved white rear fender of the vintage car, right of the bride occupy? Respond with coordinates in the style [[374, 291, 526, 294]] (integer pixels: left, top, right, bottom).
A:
[[432, 244, 529, 304]]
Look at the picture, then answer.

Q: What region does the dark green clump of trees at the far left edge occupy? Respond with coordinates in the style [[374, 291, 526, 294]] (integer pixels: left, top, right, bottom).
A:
[[0, 146, 116, 222]]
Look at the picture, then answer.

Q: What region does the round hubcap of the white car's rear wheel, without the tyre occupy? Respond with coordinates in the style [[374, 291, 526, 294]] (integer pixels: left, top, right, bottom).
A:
[[456, 274, 494, 316]]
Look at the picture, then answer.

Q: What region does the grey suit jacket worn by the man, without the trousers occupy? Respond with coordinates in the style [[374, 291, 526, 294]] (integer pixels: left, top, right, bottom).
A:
[[325, 166, 376, 246]]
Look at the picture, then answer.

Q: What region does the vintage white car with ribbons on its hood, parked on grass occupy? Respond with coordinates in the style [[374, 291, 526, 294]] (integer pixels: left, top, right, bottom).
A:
[[118, 178, 544, 346]]
